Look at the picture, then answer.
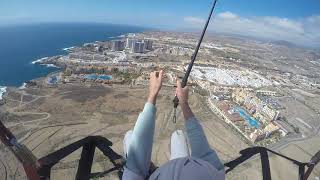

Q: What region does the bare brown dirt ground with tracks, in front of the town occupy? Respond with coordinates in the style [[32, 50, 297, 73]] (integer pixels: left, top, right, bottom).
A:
[[0, 84, 248, 179]]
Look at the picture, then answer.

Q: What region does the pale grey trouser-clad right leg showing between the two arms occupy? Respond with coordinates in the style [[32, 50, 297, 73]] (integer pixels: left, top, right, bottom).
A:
[[170, 130, 189, 160]]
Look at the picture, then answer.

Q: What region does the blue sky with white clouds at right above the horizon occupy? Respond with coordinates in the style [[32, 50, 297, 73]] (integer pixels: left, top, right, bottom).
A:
[[0, 0, 320, 47]]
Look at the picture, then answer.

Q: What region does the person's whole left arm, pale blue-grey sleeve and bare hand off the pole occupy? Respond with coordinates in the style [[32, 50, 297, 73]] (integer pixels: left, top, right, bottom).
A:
[[122, 71, 163, 177]]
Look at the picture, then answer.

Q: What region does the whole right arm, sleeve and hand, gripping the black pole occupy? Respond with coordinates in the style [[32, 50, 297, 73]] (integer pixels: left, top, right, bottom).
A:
[[176, 82, 223, 170]]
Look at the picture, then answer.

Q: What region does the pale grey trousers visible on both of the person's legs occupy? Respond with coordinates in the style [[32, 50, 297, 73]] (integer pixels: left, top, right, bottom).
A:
[[123, 130, 190, 160]]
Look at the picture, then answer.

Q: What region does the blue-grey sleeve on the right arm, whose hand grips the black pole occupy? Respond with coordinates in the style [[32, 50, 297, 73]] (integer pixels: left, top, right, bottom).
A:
[[185, 117, 223, 170]]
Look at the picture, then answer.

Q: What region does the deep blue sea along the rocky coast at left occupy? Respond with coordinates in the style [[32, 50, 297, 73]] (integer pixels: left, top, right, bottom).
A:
[[0, 23, 146, 86]]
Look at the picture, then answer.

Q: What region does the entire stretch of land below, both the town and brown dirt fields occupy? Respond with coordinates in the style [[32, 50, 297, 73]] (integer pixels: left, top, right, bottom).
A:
[[0, 31, 320, 179]]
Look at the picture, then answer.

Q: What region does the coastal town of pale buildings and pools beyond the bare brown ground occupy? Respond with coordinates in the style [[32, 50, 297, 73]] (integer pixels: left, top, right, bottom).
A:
[[26, 32, 320, 146]]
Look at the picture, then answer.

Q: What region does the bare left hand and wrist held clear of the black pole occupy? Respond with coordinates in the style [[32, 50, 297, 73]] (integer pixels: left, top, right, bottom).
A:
[[148, 70, 163, 105]]
